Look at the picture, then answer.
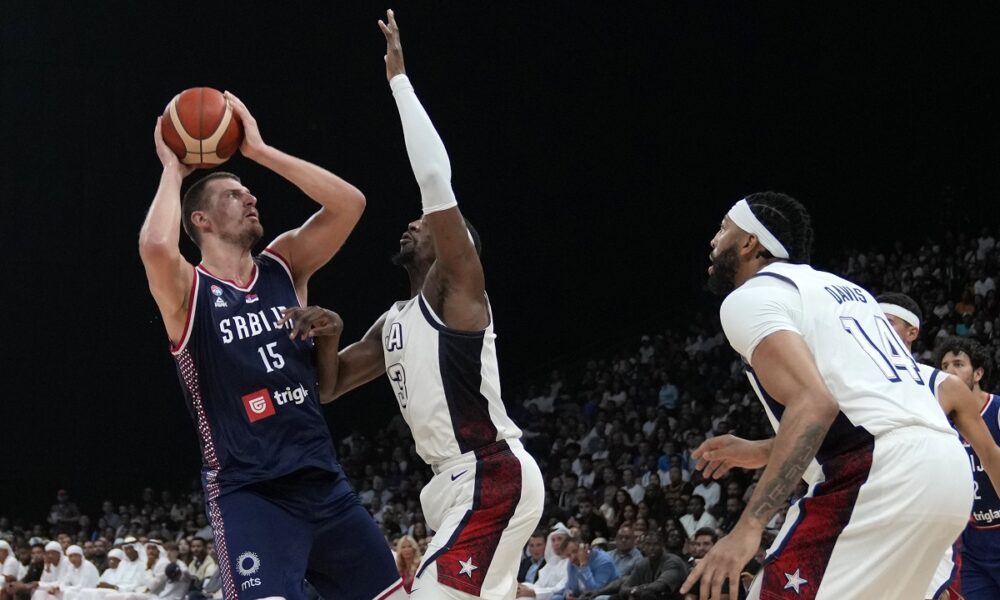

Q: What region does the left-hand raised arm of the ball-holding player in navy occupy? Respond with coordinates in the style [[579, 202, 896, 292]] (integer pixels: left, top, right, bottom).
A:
[[139, 117, 194, 343]]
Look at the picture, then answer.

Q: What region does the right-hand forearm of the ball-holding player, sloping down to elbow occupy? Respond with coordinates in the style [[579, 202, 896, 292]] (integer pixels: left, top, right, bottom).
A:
[[253, 146, 365, 216]]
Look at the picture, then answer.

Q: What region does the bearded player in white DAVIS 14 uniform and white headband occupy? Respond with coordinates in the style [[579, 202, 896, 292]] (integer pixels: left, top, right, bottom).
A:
[[681, 192, 972, 600]]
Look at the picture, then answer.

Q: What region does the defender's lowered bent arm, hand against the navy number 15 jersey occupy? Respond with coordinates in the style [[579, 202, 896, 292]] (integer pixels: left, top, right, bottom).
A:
[[278, 306, 385, 404]]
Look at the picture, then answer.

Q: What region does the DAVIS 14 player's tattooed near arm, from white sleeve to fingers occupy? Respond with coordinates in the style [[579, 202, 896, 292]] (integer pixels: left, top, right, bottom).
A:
[[681, 331, 839, 598]]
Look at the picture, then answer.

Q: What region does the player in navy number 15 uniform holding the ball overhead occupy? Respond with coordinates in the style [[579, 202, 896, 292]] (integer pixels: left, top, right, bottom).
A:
[[139, 93, 406, 600]]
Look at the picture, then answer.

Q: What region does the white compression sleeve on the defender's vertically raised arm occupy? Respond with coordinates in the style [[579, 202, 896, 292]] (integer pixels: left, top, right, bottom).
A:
[[389, 75, 458, 214]]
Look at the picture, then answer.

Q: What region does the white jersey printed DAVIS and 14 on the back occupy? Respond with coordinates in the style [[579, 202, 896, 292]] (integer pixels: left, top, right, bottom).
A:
[[721, 263, 956, 481]]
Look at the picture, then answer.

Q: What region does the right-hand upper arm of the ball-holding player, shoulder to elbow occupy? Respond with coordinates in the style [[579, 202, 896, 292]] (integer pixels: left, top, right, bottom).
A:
[[268, 206, 364, 287]]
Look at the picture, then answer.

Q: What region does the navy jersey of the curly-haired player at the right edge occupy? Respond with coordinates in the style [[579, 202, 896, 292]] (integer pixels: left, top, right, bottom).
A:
[[962, 394, 1000, 557]]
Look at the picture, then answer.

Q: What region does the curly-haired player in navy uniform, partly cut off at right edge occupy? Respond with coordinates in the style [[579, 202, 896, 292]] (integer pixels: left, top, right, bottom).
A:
[[935, 337, 1000, 600]]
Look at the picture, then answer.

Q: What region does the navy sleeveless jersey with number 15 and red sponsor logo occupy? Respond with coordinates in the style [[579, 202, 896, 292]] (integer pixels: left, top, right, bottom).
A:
[[171, 250, 340, 500]]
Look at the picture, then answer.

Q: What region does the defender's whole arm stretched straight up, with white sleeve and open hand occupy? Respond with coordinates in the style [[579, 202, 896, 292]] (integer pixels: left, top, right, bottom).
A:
[[379, 10, 489, 330]]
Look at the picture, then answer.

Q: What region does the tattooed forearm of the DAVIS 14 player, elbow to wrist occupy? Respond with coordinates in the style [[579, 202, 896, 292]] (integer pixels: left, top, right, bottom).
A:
[[740, 399, 836, 529]]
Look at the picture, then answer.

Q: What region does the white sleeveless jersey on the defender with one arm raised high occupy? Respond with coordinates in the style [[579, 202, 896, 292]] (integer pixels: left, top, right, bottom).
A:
[[382, 294, 521, 465]]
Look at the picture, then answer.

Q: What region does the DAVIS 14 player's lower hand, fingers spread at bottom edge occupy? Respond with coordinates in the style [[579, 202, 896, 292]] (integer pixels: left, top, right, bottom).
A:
[[680, 522, 761, 600]]
